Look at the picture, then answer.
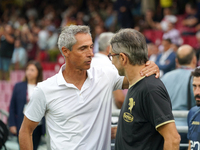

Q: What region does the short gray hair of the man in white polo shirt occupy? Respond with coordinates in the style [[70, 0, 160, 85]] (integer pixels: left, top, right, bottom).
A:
[[58, 25, 91, 55]]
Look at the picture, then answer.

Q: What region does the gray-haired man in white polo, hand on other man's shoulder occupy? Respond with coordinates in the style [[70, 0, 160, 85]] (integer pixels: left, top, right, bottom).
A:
[[19, 25, 159, 150]]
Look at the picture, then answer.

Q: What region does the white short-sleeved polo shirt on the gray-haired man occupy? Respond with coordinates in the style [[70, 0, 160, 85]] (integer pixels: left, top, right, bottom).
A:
[[25, 66, 124, 150]]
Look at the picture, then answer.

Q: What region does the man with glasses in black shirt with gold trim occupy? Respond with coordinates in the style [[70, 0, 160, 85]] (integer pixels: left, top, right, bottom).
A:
[[109, 29, 180, 150]]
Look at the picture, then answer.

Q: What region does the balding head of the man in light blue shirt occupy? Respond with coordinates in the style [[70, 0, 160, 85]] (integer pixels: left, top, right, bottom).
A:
[[176, 45, 195, 65]]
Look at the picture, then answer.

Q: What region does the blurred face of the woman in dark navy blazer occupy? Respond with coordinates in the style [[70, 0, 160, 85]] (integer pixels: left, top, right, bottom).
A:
[[25, 64, 38, 81]]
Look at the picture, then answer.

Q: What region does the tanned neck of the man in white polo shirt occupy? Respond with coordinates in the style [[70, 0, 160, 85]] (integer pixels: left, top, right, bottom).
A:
[[62, 65, 87, 90]]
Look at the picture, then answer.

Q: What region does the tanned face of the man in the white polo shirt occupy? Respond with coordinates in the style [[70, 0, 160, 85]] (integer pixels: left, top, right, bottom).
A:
[[67, 33, 94, 70]]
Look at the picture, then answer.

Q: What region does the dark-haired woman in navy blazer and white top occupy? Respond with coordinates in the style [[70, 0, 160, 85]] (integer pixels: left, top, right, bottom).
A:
[[8, 61, 45, 150]]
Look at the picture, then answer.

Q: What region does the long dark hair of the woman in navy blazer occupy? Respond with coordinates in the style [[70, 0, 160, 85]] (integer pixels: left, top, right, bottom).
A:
[[24, 60, 43, 84]]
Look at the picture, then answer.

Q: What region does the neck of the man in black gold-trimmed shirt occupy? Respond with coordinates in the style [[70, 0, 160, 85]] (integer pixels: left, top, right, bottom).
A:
[[125, 64, 145, 85]]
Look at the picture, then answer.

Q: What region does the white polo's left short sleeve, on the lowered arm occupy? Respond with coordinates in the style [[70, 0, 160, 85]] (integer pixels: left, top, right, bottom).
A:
[[25, 86, 46, 122]]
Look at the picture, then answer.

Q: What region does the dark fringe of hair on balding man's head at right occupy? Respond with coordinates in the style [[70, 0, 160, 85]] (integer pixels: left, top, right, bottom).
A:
[[176, 49, 195, 65]]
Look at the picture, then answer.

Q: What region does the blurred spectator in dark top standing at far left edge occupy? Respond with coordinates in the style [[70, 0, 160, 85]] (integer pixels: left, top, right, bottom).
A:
[[0, 24, 15, 80]]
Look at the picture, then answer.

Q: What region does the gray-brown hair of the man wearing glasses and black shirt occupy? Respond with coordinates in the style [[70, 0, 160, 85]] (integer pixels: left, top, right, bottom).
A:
[[110, 29, 148, 65]]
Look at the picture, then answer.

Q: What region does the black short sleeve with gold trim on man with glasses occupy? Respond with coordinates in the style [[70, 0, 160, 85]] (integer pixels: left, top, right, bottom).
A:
[[143, 90, 174, 129]]
